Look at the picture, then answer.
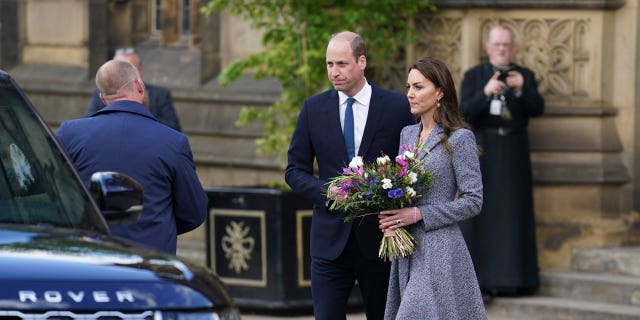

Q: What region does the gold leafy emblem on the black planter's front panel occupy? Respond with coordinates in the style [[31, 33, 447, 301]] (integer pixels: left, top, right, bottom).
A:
[[221, 221, 255, 273]]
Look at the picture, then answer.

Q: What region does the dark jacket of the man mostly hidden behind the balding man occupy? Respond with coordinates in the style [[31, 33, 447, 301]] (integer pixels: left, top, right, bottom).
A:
[[84, 82, 182, 131]]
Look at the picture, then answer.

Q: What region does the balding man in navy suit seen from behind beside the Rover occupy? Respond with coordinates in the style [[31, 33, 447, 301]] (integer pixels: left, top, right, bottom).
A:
[[56, 60, 208, 254]]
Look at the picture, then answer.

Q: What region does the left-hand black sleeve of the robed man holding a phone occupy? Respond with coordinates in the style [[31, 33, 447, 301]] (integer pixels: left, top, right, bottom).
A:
[[460, 70, 491, 123]]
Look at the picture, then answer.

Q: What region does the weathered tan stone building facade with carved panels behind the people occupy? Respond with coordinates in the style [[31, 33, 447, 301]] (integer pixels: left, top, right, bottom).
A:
[[0, 0, 640, 270]]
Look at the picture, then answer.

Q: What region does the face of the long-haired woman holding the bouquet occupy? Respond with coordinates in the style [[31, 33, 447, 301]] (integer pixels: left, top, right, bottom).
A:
[[407, 69, 442, 118]]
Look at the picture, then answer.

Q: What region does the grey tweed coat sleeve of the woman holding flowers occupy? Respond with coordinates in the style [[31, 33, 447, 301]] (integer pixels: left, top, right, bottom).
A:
[[420, 129, 482, 230]]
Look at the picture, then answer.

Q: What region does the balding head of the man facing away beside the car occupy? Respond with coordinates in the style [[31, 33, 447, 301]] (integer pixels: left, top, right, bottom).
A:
[[96, 60, 145, 105]]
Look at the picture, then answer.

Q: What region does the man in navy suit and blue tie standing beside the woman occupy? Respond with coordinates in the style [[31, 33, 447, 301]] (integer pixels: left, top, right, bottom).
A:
[[285, 31, 415, 320]]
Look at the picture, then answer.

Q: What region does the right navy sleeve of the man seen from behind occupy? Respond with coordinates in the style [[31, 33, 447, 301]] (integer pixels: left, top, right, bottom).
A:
[[173, 137, 208, 234]]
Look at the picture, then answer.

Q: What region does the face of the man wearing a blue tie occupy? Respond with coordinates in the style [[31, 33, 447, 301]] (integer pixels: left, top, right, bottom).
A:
[[326, 38, 367, 96]]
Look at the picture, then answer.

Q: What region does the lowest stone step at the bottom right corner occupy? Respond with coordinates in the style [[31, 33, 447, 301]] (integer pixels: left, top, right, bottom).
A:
[[487, 296, 640, 320]]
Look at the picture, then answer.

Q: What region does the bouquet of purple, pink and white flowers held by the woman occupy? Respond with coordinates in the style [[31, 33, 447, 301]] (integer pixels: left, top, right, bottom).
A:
[[327, 144, 432, 261]]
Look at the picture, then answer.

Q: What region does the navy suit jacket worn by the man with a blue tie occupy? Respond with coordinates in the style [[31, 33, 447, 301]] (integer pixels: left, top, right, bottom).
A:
[[285, 85, 416, 260]]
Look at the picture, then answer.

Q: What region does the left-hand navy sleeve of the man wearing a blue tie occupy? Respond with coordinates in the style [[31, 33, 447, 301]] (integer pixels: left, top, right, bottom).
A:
[[285, 103, 327, 206]]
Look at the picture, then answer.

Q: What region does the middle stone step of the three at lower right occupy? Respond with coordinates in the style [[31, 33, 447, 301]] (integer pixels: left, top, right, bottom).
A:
[[538, 272, 640, 307]]
